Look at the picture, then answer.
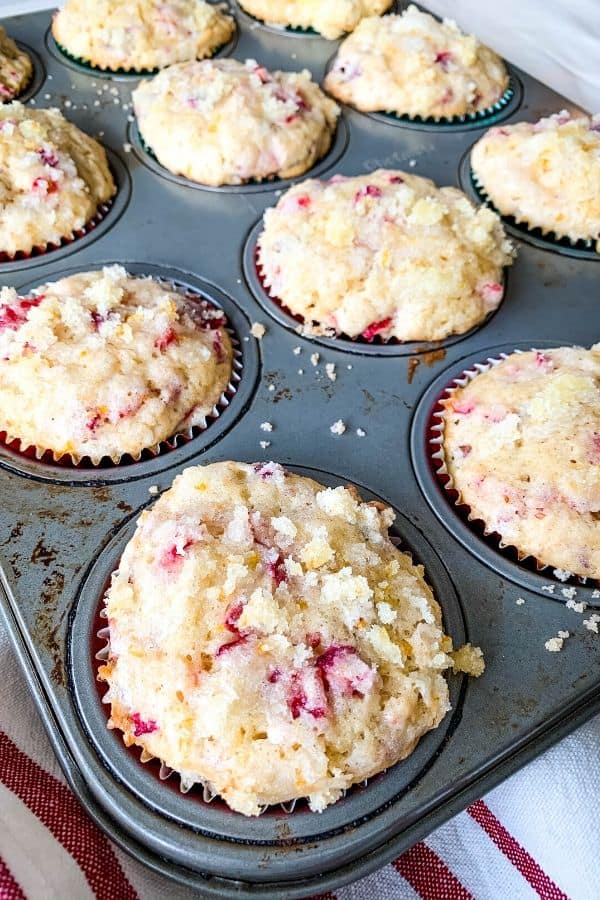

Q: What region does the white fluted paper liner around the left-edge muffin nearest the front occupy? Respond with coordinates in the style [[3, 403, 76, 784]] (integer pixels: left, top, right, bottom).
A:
[[0, 286, 243, 468]]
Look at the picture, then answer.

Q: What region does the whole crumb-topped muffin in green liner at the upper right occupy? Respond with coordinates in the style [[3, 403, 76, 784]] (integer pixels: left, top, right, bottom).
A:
[[325, 6, 509, 119]]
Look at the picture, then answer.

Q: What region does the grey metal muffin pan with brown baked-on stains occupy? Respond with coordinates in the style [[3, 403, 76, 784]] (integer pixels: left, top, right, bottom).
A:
[[0, 3, 600, 898]]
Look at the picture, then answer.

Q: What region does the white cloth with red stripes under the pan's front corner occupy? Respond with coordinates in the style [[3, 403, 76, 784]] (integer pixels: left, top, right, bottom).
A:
[[0, 632, 600, 900]]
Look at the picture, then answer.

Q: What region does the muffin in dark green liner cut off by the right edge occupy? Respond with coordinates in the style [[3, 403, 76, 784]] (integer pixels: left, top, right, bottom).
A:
[[471, 112, 600, 250]]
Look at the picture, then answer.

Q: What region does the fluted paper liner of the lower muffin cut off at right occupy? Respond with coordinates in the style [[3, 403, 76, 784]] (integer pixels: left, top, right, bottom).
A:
[[426, 347, 600, 585]]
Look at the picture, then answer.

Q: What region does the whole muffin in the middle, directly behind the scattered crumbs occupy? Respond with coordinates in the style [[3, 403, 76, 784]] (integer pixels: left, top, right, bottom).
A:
[[258, 169, 513, 341]]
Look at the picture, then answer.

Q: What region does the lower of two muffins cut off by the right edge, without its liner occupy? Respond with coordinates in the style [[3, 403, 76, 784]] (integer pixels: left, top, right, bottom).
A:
[[441, 344, 600, 578]]
